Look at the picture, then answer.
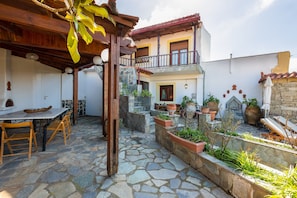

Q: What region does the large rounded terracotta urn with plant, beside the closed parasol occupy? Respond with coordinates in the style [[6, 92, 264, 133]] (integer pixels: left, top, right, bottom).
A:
[[242, 98, 261, 125]]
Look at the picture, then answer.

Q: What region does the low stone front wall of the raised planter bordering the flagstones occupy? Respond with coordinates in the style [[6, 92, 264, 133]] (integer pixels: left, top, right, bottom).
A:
[[155, 125, 270, 198]]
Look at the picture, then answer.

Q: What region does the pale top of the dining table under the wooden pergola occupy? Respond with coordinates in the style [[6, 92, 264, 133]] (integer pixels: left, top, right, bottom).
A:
[[0, 108, 68, 120]]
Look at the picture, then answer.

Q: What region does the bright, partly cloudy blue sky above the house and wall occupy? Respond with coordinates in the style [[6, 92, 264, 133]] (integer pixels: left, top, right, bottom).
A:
[[103, 0, 297, 69]]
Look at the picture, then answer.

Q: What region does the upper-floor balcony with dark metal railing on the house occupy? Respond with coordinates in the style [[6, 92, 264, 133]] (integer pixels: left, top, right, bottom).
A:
[[120, 51, 202, 75]]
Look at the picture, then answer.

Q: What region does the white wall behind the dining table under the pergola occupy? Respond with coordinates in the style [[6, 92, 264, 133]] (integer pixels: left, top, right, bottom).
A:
[[0, 49, 88, 114]]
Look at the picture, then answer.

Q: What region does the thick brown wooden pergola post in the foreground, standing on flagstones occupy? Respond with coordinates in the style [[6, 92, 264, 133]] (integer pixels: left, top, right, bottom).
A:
[[107, 35, 121, 176]]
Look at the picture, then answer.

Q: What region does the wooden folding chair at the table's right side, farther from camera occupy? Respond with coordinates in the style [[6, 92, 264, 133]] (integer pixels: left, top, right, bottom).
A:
[[46, 111, 72, 145]]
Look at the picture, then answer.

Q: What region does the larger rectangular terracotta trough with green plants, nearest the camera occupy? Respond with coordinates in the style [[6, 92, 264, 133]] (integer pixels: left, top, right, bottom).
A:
[[169, 127, 207, 153]]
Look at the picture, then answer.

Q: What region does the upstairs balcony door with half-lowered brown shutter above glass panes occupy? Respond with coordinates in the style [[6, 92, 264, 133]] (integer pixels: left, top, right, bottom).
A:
[[170, 40, 188, 65]]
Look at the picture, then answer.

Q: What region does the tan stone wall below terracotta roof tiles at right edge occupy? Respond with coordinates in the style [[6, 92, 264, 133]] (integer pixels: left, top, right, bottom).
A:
[[269, 78, 297, 124]]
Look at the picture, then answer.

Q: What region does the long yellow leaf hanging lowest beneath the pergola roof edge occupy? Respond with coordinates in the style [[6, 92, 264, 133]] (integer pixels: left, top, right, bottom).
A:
[[67, 23, 80, 63]]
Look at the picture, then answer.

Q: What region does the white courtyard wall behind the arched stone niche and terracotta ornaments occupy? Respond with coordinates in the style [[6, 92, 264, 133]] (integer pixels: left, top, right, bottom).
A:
[[201, 53, 278, 116]]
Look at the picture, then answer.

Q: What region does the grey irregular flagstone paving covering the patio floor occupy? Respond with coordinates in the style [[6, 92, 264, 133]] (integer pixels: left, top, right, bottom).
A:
[[0, 117, 232, 198]]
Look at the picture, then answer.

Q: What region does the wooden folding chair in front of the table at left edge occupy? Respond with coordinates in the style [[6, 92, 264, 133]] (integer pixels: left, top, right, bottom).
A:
[[0, 121, 37, 164]]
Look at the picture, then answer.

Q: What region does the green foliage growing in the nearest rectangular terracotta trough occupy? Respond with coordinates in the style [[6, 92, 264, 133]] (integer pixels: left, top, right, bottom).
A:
[[176, 128, 208, 143]]
